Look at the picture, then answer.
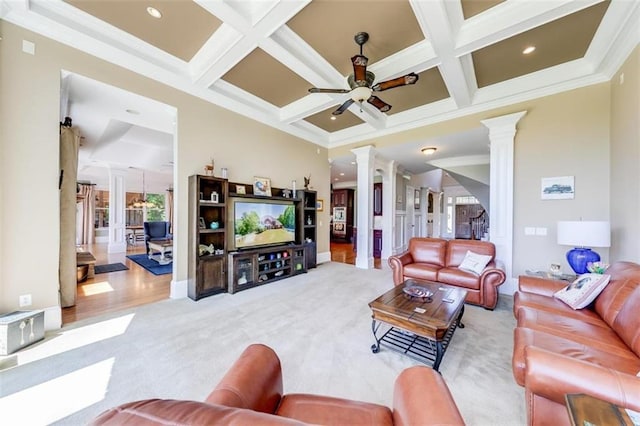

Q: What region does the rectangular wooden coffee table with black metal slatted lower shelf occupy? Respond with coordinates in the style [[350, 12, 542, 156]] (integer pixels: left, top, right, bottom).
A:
[[369, 280, 467, 371]]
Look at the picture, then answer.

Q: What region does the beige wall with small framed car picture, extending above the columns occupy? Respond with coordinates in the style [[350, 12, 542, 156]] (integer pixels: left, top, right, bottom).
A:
[[329, 83, 628, 276]]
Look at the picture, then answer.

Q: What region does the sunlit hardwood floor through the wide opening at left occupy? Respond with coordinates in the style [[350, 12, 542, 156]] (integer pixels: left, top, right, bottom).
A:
[[62, 242, 172, 325]]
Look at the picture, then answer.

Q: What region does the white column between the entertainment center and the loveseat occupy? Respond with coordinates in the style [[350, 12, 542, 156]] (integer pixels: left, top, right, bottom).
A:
[[351, 145, 376, 269]]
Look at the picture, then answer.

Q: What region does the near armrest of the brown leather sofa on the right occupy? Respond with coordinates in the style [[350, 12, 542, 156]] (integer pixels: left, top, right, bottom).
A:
[[525, 346, 640, 411]]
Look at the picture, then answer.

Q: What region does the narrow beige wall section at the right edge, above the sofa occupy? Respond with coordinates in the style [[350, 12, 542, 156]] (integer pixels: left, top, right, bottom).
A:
[[610, 47, 640, 262]]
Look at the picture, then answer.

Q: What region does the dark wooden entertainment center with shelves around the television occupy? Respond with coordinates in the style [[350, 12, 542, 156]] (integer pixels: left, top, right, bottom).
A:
[[188, 175, 317, 300]]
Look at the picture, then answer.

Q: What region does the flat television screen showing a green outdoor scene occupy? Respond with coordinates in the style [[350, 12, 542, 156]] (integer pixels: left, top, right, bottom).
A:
[[234, 201, 296, 249]]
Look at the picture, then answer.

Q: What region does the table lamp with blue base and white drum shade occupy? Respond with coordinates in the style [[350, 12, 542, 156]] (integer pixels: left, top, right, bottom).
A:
[[558, 221, 611, 274]]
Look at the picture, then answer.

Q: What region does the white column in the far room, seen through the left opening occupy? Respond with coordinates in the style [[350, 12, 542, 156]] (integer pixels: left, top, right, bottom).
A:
[[107, 168, 127, 253]]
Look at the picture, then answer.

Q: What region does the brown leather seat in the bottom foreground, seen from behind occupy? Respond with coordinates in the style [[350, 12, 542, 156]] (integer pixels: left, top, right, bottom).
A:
[[92, 344, 464, 425]]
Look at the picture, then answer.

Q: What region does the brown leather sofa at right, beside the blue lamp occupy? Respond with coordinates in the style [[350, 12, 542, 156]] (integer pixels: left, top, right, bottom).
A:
[[512, 262, 640, 425]]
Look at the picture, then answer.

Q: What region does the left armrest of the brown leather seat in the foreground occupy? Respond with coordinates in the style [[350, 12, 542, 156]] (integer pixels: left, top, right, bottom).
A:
[[205, 344, 282, 413]]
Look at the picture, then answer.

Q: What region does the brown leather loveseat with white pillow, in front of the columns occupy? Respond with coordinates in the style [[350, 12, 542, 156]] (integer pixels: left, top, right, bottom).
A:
[[389, 238, 506, 310]]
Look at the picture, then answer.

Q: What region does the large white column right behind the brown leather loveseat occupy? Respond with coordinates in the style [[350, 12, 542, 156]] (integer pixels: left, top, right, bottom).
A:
[[481, 111, 527, 294]]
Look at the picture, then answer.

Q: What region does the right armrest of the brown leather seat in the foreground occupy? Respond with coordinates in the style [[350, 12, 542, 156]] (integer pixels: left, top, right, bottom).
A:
[[393, 366, 464, 425]]
